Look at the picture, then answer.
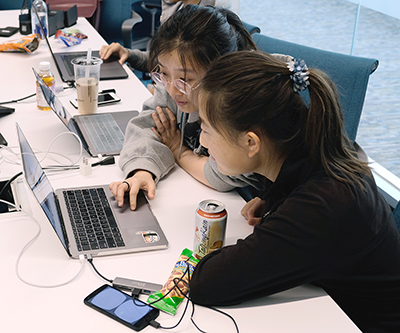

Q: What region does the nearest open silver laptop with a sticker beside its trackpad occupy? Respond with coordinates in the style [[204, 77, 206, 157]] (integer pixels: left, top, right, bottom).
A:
[[16, 124, 168, 259]]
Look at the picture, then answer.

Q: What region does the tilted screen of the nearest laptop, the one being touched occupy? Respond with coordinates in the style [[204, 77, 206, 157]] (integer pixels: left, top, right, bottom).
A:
[[16, 124, 67, 249]]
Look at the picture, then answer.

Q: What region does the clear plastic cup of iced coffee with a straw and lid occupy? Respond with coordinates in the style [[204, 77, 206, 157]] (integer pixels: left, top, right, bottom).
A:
[[72, 52, 103, 114]]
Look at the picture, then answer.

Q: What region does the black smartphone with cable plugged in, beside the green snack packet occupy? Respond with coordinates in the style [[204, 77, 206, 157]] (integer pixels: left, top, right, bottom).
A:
[[83, 284, 160, 331]]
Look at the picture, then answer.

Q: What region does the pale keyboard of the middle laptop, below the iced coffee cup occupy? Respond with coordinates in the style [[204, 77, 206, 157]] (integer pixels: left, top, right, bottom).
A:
[[80, 113, 124, 153]]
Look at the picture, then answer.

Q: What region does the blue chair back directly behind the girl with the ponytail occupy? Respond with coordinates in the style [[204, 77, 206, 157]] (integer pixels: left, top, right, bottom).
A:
[[252, 33, 379, 142]]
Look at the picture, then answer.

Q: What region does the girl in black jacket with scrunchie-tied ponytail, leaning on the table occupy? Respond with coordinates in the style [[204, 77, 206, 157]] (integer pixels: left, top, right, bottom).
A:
[[190, 51, 400, 332]]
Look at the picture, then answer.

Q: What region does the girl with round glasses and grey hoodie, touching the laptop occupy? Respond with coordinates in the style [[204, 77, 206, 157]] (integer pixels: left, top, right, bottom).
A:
[[110, 5, 259, 210]]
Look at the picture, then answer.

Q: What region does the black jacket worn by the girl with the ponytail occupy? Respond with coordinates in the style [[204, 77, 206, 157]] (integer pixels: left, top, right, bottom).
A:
[[190, 156, 400, 333]]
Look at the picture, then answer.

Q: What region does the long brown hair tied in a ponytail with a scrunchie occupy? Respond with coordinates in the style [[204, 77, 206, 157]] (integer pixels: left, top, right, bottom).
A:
[[200, 51, 369, 186]]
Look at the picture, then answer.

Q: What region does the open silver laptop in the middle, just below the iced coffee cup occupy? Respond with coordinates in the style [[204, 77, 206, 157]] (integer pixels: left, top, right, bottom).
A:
[[33, 69, 139, 156]]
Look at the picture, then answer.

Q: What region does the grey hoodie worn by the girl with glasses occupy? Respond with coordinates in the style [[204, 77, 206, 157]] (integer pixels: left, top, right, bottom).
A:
[[119, 89, 261, 191]]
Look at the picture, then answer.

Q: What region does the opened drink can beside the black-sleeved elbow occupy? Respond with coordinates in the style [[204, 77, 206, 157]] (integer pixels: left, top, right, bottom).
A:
[[194, 200, 228, 259]]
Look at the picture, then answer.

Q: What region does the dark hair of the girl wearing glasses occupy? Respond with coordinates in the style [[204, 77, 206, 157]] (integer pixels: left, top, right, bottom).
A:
[[148, 5, 256, 70]]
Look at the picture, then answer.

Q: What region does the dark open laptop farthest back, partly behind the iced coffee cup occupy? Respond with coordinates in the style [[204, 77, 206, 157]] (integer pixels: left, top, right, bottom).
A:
[[32, 6, 128, 82]]
